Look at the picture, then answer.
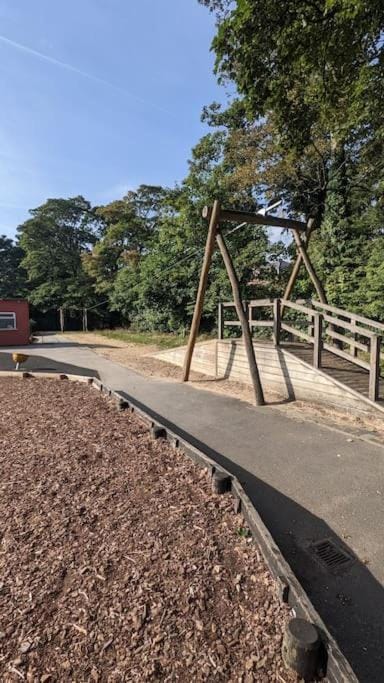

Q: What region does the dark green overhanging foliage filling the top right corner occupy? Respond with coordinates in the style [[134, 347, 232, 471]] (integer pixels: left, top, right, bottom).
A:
[[204, 0, 384, 149]]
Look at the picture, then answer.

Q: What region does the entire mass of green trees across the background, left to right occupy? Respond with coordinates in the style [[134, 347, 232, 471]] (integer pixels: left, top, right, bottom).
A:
[[0, 0, 384, 331]]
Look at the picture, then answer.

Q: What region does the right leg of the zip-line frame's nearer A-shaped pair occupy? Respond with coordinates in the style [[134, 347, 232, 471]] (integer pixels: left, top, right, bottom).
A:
[[216, 232, 265, 406]]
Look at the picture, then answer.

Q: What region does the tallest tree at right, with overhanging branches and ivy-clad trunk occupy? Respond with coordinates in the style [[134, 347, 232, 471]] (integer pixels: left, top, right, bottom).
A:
[[201, 0, 384, 307]]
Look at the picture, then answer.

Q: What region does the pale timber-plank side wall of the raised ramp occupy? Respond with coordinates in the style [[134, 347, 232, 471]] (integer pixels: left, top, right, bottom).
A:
[[155, 339, 374, 413]]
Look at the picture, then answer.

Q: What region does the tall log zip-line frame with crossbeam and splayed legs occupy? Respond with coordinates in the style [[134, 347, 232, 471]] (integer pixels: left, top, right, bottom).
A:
[[183, 200, 327, 406]]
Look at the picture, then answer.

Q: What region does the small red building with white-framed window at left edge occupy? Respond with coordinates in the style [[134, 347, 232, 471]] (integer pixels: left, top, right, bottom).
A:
[[0, 299, 30, 346]]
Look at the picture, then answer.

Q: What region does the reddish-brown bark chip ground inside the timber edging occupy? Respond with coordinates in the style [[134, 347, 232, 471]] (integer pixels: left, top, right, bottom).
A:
[[0, 378, 296, 683]]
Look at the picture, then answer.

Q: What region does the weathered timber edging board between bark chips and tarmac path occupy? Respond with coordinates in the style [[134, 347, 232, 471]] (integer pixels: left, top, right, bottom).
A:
[[90, 378, 358, 683]]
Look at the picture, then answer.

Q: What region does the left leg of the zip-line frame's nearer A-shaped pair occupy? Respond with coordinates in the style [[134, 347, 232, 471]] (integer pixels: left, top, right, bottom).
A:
[[183, 200, 220, 382]]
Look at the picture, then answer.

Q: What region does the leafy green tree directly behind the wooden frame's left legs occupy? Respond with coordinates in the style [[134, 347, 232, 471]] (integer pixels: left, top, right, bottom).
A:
[[112, 130, 284, 331]]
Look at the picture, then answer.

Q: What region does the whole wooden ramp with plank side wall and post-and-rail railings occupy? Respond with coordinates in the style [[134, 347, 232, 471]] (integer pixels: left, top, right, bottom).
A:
[[156, 299, 384, 413]]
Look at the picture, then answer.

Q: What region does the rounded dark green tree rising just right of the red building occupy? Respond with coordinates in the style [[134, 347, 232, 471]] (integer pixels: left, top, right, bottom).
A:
[[18, 196, 100, 310]]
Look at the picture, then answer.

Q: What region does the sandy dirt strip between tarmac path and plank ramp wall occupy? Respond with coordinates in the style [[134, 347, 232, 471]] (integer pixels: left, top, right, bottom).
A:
[[65, 332, 384, 444]]
